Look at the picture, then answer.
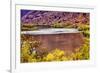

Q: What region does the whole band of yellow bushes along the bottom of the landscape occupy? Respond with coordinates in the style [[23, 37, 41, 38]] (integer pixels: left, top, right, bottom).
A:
[[21, 38, 90, 63]]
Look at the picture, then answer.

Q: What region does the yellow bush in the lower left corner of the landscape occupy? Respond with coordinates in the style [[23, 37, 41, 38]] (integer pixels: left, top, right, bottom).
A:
[[21, 41, 36, 63]]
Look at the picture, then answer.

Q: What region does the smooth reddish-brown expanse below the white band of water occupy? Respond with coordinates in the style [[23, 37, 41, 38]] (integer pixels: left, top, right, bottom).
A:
[[22, 33, 84, 51]]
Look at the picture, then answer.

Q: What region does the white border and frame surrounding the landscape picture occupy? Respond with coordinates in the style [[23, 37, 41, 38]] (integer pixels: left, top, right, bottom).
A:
[[11, 4, 96, 73]]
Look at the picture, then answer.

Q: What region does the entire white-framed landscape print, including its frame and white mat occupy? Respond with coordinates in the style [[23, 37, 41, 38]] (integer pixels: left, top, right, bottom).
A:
[[11, 0, 95, 73]]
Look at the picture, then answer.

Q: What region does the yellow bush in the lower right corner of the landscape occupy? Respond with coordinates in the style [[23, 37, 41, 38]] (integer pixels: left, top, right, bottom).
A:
[[71, 39, 90, 60]]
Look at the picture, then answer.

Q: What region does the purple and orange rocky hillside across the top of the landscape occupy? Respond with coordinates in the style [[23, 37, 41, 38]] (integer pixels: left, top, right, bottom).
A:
[[21, 10, 89, 25]]
